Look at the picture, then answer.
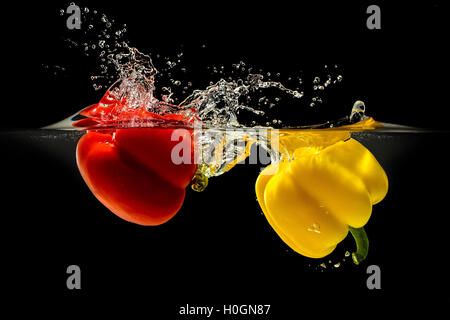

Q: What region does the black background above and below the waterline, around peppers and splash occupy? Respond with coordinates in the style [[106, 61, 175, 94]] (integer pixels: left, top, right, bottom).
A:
[[0, 1, 449, 319]]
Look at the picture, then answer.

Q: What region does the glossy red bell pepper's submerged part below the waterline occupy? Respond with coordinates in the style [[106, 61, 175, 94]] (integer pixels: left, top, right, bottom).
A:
[[77, 128, 196, 226]]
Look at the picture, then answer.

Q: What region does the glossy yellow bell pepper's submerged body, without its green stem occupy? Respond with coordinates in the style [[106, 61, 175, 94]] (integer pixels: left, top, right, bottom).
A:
[[256, 139, 388, 258]]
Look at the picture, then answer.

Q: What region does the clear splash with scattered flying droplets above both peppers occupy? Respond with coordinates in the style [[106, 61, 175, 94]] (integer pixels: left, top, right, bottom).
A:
[[45, 10, 420, 177]]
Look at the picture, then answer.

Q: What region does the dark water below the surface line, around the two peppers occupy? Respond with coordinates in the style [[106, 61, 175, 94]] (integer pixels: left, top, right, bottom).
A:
[[0, 130, 450, 319]]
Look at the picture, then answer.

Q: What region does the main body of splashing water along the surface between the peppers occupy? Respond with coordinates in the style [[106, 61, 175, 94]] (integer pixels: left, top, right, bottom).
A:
[[42, 41, 408, 177]]
